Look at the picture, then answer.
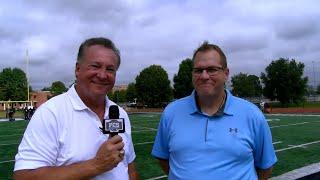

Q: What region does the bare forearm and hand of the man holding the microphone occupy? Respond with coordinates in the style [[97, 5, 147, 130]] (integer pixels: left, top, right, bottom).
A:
[[13, 136, 124, 180]]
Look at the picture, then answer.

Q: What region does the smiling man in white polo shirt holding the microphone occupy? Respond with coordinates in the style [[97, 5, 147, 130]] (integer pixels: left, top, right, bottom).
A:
[[14, 38, 137, 180]]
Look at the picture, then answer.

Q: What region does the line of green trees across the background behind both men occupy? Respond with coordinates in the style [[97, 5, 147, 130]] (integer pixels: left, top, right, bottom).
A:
[[0, 58, 320, 107]]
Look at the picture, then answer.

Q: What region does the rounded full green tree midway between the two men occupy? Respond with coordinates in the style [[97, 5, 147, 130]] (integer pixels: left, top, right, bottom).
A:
[[136, 65, 172, 107]]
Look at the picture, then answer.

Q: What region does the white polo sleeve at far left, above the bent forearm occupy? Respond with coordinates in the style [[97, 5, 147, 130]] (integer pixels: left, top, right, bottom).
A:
[[14, 106, 59, 171]]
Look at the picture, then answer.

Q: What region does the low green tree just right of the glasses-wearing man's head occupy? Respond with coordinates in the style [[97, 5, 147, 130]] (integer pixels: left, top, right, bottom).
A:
[[231, 73, 262, 97]]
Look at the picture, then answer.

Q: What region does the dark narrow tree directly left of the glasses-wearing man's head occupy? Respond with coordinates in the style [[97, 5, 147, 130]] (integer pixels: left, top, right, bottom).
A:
[[173, 58, 193, 98]]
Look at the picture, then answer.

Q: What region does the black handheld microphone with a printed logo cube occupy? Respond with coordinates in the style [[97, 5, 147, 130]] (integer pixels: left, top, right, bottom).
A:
[[102, 105, 125, 137]]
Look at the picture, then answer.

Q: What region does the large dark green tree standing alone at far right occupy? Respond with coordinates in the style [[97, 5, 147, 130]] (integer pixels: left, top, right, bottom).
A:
[[261, 58, 308, 105]]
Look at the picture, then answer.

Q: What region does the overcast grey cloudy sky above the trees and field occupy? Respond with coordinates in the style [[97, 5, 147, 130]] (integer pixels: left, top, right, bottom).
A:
[[0, 0, 320, 89]]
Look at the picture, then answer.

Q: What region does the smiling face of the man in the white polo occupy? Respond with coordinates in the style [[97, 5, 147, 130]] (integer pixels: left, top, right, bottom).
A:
[[75, 45, 118, 96]]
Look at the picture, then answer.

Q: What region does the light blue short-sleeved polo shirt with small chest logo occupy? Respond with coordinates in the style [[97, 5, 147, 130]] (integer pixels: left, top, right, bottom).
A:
[[152, 90, 277, 180]]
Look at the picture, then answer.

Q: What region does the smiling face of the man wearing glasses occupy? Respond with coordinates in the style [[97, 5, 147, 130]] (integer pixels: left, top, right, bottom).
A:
[[192, 50, 229, 97]]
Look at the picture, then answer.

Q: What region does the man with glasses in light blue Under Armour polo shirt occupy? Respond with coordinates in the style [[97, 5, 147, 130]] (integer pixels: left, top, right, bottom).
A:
[[152, 42, 277, 180]]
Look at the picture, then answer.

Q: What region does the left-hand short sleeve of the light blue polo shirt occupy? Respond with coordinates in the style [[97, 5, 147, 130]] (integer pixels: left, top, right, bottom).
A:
[[151, 111, 169, 159]]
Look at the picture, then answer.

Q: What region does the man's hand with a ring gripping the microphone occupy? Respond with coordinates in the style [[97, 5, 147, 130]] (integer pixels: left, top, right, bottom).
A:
[[93, 135, 124, 173]]
